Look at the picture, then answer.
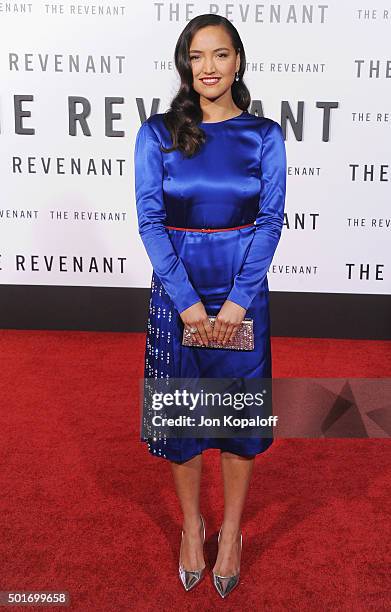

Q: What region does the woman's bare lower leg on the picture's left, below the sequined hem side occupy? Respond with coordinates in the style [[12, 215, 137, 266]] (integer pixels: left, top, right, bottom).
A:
[[171, 453, 205, 570]]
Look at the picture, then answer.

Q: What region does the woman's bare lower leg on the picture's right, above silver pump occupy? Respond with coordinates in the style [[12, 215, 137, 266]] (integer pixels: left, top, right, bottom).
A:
[[213, 451, 254, 576]]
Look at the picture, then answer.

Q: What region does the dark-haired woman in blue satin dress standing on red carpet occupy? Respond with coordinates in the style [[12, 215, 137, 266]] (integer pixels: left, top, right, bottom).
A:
[[134, 14, 286, 597]]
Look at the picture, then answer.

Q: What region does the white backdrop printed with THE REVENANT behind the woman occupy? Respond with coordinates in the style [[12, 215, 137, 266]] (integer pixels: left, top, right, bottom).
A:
[[0, 0, 391, 294]]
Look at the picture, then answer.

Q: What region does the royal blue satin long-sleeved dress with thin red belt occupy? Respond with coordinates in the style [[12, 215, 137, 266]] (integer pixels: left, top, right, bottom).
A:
[[134, 111, 286, 462]]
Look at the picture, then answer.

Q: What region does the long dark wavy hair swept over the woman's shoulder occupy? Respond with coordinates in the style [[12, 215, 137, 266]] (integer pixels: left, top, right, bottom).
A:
[[161, 13, 251, 157]]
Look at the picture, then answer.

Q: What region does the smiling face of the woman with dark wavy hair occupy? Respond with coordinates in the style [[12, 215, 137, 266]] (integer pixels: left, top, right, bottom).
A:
[[189, 26, 240, 100]]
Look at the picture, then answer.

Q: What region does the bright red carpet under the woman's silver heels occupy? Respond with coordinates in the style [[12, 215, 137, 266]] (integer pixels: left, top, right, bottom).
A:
[[0, 330, 391, 612]]
